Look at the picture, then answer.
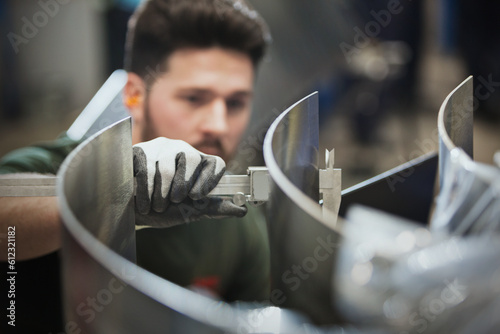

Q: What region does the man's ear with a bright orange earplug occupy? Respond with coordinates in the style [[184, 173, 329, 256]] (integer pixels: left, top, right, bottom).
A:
[[123, 72, 146, 124]]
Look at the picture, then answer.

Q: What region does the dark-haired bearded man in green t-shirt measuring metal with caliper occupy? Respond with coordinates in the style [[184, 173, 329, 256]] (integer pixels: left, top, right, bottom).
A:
[[0, 0, 269, 330]]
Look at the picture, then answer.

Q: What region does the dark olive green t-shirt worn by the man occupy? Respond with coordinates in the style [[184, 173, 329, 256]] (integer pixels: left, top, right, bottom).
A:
[[0, 134, 270, 301]]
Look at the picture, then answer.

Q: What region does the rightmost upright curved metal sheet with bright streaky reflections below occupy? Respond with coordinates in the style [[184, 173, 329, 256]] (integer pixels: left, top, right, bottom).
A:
[[431, 77, 500, 236]]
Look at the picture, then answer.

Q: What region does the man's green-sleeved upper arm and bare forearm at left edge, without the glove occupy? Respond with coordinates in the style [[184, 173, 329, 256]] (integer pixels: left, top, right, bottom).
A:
[[0, 134, 79, 261]]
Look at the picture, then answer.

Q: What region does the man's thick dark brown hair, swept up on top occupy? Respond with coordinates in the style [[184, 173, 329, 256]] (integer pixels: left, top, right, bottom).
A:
[[125, 0, 271, 79]]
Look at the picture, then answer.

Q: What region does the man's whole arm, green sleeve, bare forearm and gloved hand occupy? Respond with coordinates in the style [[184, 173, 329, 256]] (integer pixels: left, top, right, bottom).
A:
[[0, 138, 247, 261]]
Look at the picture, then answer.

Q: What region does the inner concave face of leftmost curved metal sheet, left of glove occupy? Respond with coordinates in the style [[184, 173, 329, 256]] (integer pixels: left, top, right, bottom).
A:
[[56, 118, 135, 261]]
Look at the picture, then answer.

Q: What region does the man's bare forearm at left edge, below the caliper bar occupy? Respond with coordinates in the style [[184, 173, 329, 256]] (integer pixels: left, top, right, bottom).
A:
[[0, 197, 61, 261]]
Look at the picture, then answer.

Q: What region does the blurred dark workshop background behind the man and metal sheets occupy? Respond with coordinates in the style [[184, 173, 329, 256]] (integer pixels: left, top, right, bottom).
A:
[[0, 0, 500, 188]]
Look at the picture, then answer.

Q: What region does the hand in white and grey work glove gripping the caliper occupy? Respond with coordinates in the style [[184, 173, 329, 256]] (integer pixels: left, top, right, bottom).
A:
[[133, 137, 247, 227]]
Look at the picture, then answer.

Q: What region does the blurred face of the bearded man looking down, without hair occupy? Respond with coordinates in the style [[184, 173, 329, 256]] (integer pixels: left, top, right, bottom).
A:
[[126, 47, 254, 162]]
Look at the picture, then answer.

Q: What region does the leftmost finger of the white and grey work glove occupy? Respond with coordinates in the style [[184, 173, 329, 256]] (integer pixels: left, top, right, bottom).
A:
[[133, 147, 154, 214]]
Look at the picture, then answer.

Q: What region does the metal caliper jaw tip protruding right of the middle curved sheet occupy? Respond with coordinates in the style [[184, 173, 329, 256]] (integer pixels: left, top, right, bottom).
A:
[[319, 150, 342, 223]]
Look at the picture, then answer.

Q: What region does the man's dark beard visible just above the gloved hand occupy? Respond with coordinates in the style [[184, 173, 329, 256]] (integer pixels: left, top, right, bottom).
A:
[[141, 95, 232, 163]]
